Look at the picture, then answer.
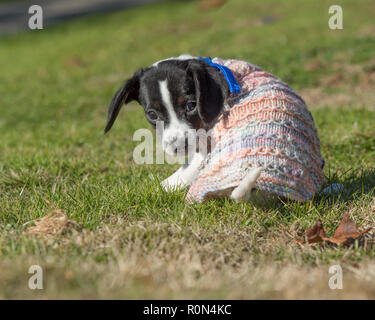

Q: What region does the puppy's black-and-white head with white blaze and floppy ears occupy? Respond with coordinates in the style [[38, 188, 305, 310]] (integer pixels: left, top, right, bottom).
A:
[[105, 56, 229, 155]]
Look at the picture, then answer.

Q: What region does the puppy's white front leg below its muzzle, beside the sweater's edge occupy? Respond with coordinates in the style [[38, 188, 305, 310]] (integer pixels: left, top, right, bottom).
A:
[[161, 153, 204, 191]]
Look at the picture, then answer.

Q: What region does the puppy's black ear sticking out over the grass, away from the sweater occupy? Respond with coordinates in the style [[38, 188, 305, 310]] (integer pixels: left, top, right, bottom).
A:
[[104, 69, 144, 133]]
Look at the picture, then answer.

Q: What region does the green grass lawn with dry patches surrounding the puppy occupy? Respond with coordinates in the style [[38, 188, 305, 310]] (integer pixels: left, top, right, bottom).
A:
[[0, 0, 375, 299]]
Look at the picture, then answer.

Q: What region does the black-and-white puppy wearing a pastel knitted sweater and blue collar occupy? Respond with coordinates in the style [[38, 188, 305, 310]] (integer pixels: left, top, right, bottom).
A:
[[105, 55, 322, 201]]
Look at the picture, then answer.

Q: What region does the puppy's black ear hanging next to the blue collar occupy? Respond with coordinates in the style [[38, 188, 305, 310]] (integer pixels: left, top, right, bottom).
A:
[[187, 61, 228, 124]]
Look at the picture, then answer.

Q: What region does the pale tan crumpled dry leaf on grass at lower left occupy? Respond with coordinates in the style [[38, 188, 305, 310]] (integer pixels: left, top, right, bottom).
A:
[[24, 209, 76, 237]]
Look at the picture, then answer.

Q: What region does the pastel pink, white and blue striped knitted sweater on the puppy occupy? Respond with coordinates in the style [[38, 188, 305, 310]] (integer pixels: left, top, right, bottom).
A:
[[187, 58, 324, 202]]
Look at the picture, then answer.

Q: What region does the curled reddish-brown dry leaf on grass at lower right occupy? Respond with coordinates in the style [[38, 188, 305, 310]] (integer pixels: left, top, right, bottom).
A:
[[297, 212, 372, 245]]
